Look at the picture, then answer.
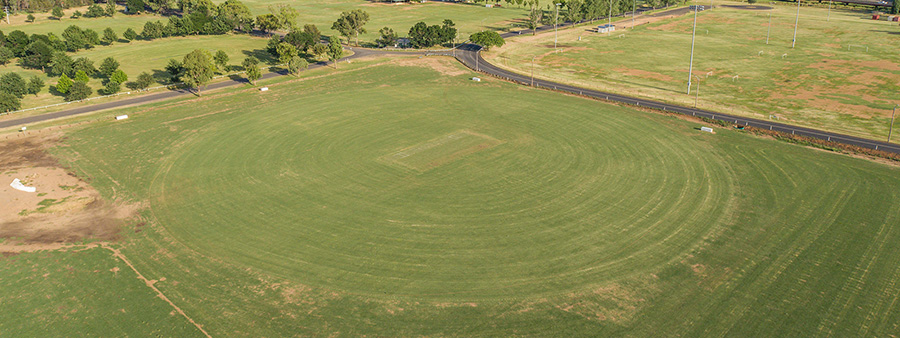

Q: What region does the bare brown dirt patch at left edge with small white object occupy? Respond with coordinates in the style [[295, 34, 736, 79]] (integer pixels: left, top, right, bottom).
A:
[[0, 135, 138, 251]]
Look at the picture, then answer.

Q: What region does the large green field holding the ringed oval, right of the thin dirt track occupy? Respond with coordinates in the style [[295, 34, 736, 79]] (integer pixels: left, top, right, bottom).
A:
[[2, 58, 880, 337]]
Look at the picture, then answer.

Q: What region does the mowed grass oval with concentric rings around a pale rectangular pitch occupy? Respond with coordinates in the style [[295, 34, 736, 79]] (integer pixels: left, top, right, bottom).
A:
[[152, 74, 732, 299]]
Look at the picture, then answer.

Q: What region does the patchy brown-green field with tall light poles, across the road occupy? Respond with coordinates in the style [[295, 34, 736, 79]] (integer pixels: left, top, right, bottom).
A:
[[488, 2, 900, 140]]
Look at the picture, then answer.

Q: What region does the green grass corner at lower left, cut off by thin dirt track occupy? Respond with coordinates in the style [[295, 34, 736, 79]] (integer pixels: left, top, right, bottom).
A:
[[0, 248, 197, 337]]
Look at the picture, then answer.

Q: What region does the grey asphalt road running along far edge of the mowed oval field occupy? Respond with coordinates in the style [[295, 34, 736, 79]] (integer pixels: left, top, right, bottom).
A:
[[0, 15, 900, 154]]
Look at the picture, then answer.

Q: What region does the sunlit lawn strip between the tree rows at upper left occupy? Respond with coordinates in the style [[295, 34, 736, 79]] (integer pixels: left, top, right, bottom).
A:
[[0, 34, 275, 108]]
